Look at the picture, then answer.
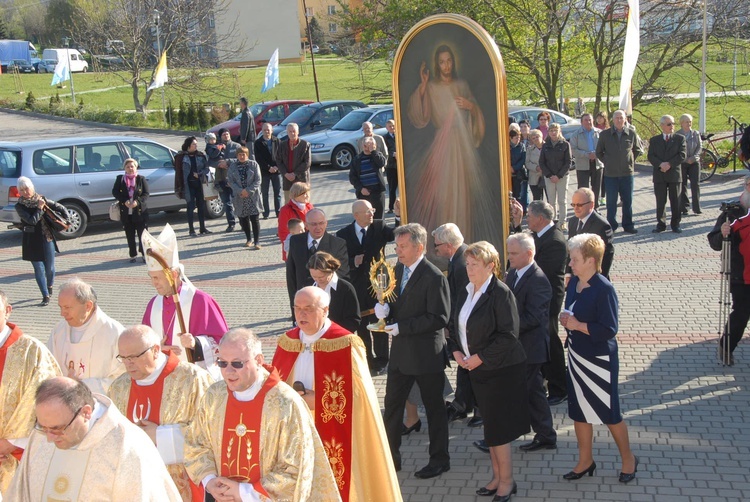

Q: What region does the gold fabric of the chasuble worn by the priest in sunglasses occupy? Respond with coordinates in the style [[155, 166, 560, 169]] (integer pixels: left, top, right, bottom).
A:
[[185, 369, 341, 502]]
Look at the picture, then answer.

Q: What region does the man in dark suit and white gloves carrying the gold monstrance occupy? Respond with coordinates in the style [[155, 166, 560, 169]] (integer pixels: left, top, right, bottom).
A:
[[375, 223, 450, 479]]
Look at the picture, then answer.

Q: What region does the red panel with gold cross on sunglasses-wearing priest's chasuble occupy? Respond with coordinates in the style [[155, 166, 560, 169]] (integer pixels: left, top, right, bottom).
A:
[[220, 361, 280, 497]]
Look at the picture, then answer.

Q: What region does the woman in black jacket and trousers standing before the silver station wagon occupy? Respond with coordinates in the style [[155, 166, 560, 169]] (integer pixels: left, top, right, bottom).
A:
[[112, 159, 149, 263]]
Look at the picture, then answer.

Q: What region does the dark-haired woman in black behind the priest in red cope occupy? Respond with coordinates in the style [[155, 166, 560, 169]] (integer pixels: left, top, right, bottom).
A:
[[307, 251, 362, 333]]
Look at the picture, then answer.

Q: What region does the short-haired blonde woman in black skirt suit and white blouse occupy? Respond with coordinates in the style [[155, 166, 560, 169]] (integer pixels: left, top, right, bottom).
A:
[[448, 241, 529, 502]]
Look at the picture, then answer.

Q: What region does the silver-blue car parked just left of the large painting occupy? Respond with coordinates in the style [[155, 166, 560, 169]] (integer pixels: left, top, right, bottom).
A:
[[302, 105, 393, 169]]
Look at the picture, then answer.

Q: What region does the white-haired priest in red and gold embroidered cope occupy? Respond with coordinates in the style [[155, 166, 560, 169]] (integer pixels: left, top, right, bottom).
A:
[[273, 286, 401, 502]]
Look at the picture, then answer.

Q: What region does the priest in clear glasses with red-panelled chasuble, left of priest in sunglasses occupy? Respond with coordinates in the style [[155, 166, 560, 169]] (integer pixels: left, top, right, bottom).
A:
[[109, 325, 213, 502]]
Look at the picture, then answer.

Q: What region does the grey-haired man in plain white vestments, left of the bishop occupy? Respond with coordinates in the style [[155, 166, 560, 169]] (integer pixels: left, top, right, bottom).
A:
[[47, 278, 125, 394]]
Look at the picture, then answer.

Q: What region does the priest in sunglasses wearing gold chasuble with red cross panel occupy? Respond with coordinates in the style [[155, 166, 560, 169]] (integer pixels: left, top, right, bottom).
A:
[[185, 328, 340, 502]]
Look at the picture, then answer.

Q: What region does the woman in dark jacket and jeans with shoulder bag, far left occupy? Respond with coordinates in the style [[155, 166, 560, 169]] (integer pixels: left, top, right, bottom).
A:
[[16, 176, 68, 307]]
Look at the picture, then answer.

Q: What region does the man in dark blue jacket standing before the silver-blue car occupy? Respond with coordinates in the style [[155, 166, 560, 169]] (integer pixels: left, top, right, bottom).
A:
[[349, 137, 386, 220]]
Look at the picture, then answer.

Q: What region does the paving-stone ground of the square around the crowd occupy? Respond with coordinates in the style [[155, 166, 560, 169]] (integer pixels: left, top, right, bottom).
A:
[[0, 113, 750, 502]]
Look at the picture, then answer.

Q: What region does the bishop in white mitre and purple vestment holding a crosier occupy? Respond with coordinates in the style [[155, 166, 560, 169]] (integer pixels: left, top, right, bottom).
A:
[[141, 223, 228, 377]]
